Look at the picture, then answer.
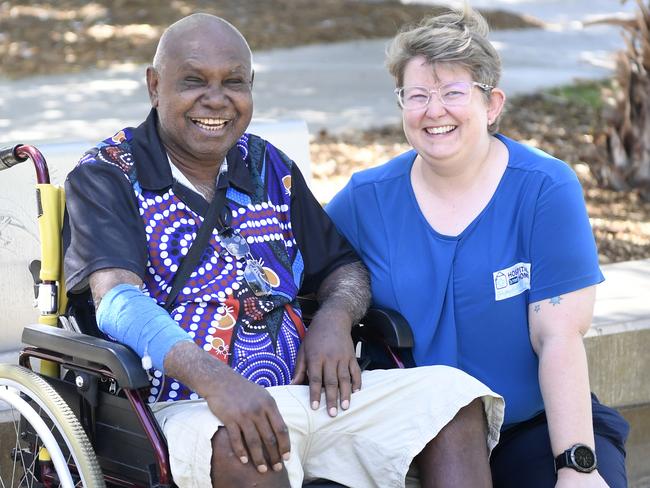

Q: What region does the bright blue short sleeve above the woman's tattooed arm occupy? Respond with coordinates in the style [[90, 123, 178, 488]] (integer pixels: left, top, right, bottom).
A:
[[529, 176, 604, 302]]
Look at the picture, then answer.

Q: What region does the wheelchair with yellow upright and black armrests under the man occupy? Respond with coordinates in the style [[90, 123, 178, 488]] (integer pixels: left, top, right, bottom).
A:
[[0, 145, 413, 488]]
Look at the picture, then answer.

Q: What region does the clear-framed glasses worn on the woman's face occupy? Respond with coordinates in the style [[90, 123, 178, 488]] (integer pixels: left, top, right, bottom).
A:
[[395, 81, 494, 110]]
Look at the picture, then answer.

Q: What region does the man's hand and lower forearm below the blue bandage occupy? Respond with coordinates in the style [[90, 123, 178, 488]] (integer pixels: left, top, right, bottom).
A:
[[165, 342, 291, 473]]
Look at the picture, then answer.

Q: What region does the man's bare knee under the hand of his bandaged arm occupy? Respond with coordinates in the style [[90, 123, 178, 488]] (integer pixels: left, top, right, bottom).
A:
[[211, 428, 289, 488]]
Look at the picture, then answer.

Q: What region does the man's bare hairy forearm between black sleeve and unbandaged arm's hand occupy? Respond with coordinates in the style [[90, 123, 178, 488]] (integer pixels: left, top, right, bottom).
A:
[[316, 261, 370, 323]]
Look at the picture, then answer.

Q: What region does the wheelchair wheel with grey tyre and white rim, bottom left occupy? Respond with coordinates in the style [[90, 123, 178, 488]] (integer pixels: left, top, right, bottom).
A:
[[0, 364, 105, 488]]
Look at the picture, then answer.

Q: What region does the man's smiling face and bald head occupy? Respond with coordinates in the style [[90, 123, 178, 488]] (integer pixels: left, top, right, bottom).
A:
[[147, 19, 253, 164]]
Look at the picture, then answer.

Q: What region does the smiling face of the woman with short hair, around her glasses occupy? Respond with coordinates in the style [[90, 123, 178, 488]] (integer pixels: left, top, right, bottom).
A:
[[402, 56, 504, 171]]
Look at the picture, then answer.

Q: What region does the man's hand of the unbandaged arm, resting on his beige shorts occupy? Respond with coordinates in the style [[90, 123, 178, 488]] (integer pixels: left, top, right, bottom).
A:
[[291, 309, 361, 417]]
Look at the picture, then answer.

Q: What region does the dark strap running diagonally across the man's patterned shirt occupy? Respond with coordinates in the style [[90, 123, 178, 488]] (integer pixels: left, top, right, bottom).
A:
[[164, 163, 229, 312]]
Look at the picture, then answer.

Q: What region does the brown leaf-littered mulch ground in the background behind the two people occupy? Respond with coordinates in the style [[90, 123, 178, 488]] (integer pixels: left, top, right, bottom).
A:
[[0, 0, 650, 263]]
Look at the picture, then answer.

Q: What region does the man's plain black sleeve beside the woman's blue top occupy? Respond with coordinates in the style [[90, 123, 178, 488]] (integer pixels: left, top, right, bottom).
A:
[[291, 164, 359, 294]]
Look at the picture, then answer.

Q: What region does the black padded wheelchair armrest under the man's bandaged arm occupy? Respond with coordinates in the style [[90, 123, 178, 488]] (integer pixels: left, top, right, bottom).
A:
[[22, 324, 149, 389]]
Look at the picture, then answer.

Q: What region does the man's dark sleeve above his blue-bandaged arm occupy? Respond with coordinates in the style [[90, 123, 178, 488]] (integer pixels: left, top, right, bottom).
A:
[[64, 162, 147, 293]]
